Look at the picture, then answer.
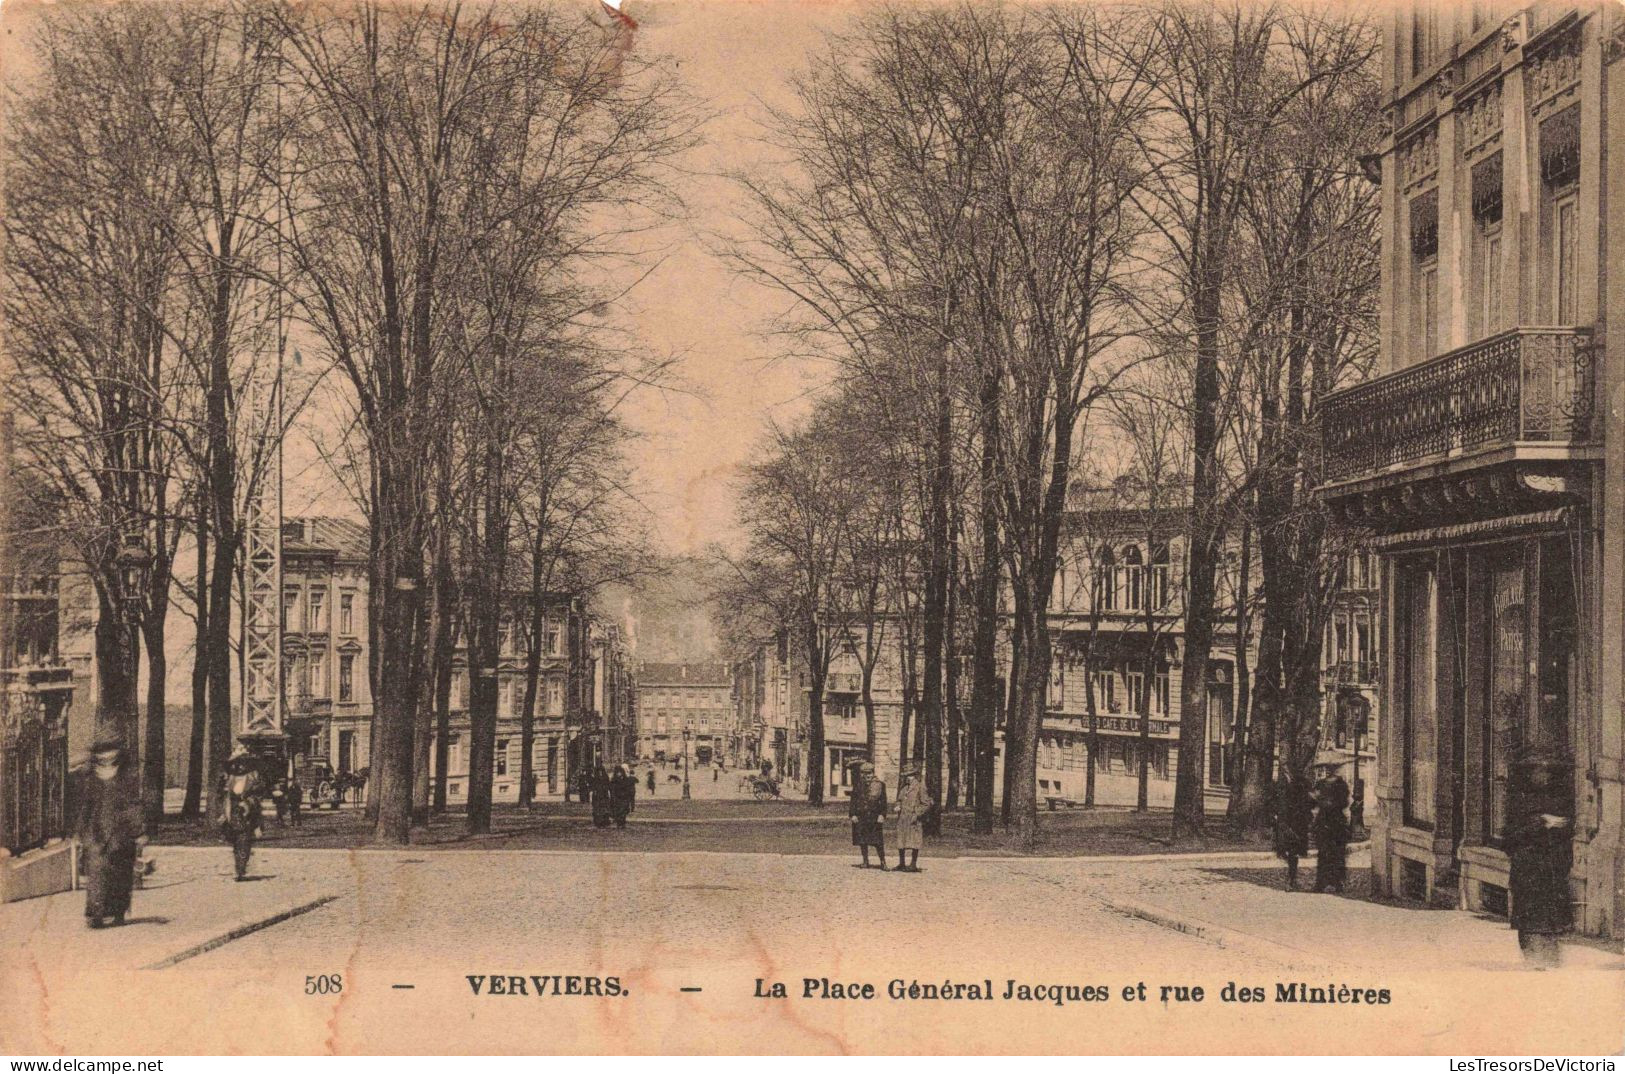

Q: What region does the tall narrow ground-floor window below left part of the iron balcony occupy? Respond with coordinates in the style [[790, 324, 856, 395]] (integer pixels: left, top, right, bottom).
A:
[[1398, 564, 1438, 829]]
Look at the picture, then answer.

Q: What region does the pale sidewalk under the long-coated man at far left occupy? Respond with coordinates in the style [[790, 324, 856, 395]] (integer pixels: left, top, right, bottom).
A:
[[0, 845, 343, 978]]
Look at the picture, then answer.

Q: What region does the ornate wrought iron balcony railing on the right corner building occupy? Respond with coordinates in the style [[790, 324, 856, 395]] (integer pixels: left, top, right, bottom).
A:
[[1321, 328, 1596, 483]]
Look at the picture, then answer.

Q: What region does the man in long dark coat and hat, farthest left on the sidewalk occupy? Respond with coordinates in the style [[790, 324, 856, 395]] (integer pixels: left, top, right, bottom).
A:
[[73, 738, 146, 928]]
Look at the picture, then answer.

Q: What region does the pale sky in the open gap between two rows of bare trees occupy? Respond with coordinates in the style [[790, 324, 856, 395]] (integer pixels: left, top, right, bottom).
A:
[[611, 0, 860, 552]]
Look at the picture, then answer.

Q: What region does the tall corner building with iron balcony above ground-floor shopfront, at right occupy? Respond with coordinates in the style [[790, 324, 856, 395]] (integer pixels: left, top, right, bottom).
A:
[[1320, 3, 1625, 936]]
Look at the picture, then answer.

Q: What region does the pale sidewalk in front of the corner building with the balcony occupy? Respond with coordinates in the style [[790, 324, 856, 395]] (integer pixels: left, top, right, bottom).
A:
[[1108, 851, 1625, 973]]
